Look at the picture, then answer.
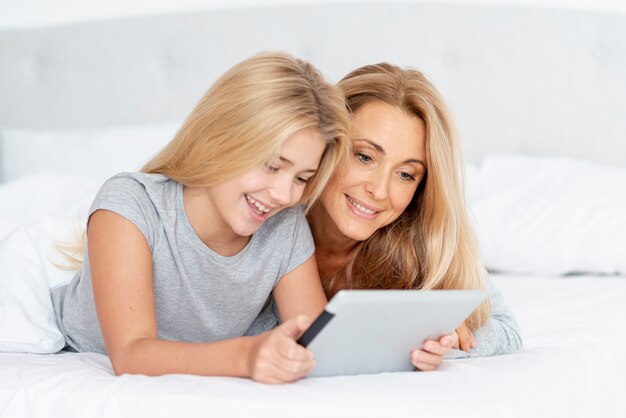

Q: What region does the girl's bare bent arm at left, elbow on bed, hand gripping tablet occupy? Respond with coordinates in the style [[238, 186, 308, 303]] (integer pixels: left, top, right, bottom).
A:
[[87, 210, 314, 383]]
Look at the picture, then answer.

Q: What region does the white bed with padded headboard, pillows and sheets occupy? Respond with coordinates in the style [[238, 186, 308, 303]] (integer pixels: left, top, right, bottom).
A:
[[0, 1, 626, 418]]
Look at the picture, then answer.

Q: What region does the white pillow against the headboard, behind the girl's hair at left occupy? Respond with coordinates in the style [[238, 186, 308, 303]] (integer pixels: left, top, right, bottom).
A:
[[0, 123, 180, 181]]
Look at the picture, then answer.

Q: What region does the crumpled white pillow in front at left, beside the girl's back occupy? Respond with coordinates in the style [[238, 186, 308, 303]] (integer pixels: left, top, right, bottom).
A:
[[0, 215, 80, 354]]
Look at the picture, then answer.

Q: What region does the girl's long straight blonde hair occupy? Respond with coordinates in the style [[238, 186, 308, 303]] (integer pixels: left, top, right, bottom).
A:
[[57, 52, 350, 270]]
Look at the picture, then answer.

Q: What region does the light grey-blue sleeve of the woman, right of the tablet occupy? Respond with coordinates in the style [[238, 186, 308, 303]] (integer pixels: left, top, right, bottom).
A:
[[446, 278, 522, 359]]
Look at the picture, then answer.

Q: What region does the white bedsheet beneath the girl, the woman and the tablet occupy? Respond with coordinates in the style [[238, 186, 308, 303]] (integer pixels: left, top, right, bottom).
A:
[[0, 276, 626, 418]]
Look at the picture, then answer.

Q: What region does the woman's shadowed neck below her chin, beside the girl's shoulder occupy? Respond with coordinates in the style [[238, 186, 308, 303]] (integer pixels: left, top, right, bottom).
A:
[[308, 204, 359, 283]]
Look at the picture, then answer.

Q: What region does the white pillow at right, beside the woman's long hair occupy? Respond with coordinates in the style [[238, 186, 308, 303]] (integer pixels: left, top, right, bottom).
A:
[[469, 155, 626, 274]]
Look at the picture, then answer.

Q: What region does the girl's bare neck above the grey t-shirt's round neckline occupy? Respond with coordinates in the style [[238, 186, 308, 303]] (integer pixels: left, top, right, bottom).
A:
[[183, 186, 250, 257]]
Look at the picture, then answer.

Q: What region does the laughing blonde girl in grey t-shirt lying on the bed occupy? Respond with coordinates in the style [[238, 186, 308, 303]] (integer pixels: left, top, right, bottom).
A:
[[52, 53, 349, 383]]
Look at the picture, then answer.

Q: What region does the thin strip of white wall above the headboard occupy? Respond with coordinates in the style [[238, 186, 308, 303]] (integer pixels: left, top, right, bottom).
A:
[[0, 0, 626, 29]]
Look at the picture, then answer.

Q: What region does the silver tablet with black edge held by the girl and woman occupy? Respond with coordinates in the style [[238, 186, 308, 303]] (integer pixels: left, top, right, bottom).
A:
[[298, 290, 487, 377]]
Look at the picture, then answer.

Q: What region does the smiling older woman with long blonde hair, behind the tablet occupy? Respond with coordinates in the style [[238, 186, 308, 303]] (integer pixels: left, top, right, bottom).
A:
[[249, 63, 521, 370]]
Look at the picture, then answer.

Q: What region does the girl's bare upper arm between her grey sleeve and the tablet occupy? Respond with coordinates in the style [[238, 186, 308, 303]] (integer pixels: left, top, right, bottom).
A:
[[272, 254, 328, 322]]
